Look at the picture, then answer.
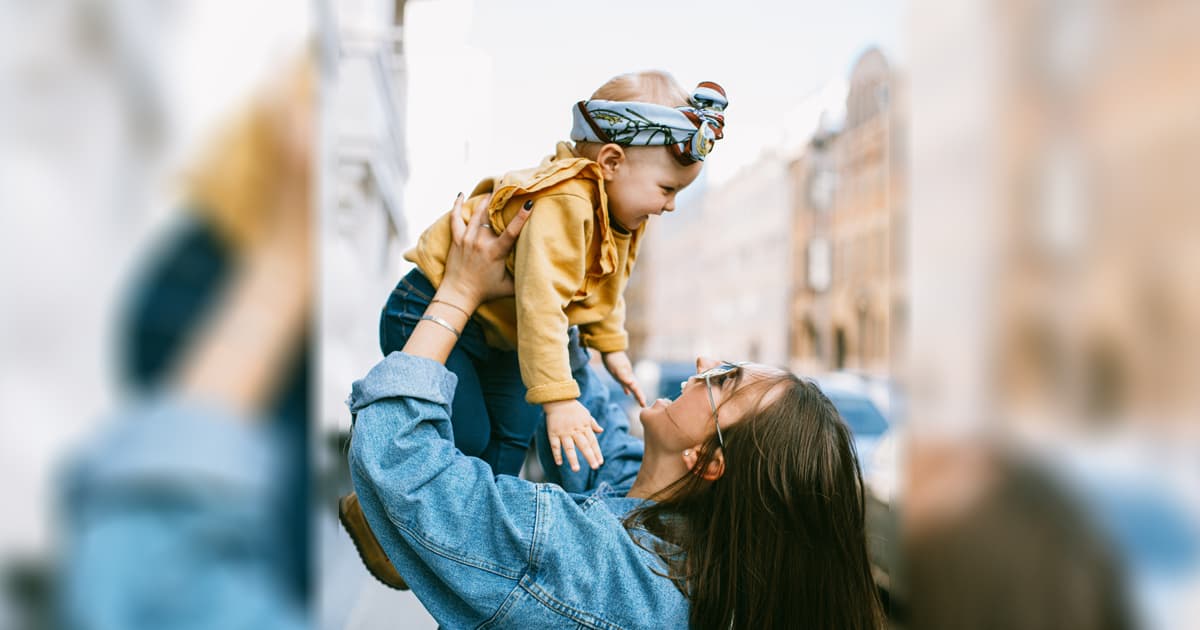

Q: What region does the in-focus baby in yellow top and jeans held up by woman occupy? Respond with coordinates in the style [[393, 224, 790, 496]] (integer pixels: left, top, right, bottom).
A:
[[379, 72, 727, 475]]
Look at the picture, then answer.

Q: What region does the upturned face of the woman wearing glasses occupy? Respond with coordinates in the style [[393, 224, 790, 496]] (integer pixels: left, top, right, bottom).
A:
[[641, 356, 782, 451]]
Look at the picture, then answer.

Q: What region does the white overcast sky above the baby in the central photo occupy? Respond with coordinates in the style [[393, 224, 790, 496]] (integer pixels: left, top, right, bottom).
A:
[[404, 0, 906, 230]]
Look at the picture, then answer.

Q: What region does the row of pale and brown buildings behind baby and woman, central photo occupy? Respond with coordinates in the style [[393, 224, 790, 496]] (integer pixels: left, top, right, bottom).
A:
[[626, 48, 908, 373]]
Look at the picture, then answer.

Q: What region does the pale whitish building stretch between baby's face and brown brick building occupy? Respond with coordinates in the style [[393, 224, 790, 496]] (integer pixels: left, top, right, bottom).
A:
[[625, 152, 791, 365]]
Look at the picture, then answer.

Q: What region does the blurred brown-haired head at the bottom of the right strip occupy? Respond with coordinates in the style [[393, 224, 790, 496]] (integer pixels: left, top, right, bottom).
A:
[[900, 442, 1132, 630]]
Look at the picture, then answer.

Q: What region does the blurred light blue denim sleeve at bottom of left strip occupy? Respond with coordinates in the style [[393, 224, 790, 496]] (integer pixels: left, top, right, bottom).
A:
[[62, 398, 306, 630]]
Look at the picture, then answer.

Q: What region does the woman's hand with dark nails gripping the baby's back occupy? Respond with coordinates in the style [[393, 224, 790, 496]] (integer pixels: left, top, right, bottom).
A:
[[438, 193, 533, 312]]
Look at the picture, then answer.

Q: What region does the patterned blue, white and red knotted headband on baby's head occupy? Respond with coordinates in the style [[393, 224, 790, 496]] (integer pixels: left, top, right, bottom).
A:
[[571, 82, 728, 166]]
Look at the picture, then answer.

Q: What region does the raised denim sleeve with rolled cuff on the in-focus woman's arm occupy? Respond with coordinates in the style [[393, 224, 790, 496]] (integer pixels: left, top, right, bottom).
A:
[[347, 353, 536, 628]]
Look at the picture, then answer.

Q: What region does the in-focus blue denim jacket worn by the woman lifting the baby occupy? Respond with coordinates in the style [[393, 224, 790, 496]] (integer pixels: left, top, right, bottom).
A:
[[347, 336, 689, 629]]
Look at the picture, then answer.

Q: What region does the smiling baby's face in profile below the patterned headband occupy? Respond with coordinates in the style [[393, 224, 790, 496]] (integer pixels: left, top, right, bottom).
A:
[[606, 146, 703, 230]]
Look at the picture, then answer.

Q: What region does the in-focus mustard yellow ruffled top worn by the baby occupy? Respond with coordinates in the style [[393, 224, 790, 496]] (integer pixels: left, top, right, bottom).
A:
[[404, 143, 646, 404]]
